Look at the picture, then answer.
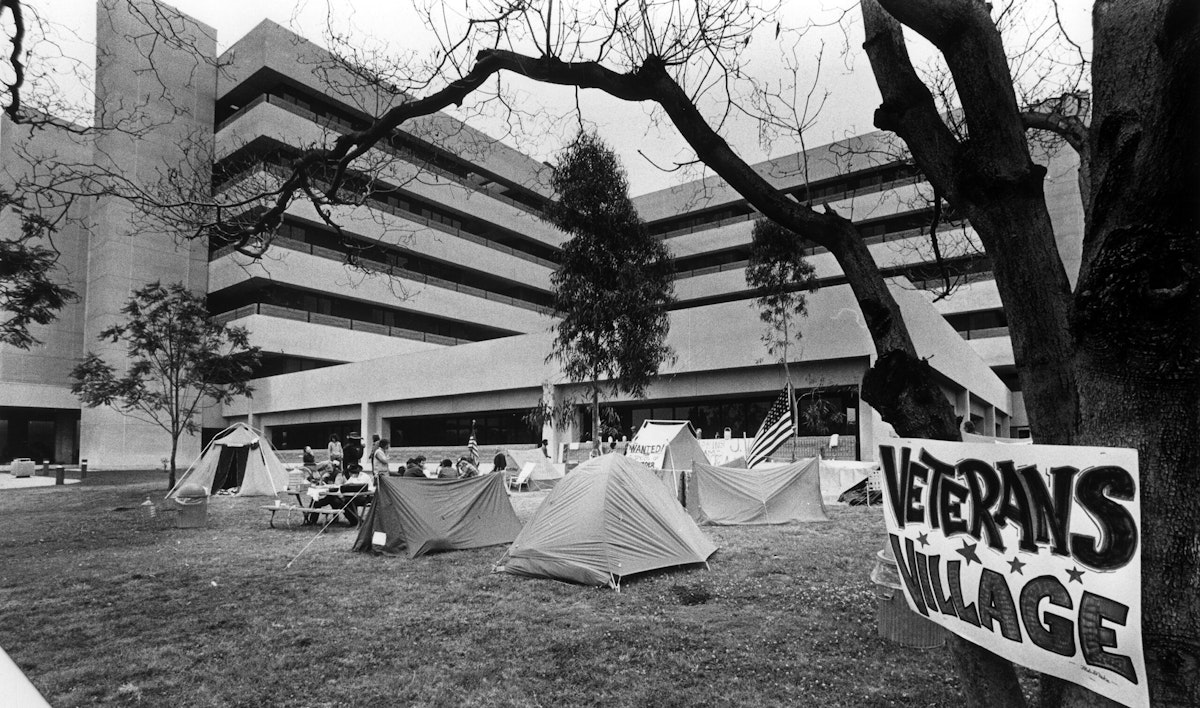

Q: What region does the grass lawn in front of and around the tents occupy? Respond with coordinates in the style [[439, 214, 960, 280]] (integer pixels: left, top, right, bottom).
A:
[[0, 473, 1012, 707]]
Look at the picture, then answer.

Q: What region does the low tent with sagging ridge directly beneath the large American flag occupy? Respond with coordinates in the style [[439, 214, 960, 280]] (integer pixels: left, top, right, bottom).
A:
[[688, 457, 829, 526]]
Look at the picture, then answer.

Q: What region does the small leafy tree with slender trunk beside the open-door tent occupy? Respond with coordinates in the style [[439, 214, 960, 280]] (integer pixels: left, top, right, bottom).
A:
[[71, 283, 260, 487]]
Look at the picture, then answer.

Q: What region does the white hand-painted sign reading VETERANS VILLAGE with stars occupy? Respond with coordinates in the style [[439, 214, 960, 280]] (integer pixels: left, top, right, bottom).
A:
[[880, 439, 1150, 708]]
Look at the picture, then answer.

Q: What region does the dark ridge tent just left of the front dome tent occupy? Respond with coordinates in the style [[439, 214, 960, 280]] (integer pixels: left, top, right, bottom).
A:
[[354, 474, 521, 558]]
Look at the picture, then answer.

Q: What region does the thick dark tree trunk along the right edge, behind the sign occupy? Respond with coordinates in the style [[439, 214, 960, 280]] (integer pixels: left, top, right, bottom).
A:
[[1062, 0, 1200, 707]]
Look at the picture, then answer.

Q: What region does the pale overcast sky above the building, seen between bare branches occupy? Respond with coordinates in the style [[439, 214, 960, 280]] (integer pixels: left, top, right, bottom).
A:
[[32, 0, 1088, 194]]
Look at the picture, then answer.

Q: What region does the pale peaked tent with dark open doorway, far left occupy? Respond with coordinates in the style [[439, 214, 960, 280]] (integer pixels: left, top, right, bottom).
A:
[[167, 422, 288, 497]]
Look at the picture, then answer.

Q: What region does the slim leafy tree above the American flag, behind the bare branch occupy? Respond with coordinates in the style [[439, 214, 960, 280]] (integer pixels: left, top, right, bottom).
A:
[[746, 218, 817, 382]]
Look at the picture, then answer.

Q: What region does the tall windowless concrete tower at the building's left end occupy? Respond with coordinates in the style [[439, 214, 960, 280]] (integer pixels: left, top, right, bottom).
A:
[[80, 0, 216, 468]]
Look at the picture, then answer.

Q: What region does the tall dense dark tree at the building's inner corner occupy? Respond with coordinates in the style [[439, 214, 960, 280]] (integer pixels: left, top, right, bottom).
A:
[[546, 132, 674, 456]]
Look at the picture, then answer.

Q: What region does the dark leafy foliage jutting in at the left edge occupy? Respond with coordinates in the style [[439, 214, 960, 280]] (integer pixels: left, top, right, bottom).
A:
[[0, 191, 77, 349]]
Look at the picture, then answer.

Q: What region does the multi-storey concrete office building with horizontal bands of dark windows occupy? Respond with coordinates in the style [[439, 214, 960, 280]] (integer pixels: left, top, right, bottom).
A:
[[0, 1, 1082, 467]]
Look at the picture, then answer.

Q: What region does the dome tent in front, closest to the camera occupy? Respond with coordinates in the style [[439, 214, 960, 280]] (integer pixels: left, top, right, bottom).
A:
[[496, 454, 716, 588]]
